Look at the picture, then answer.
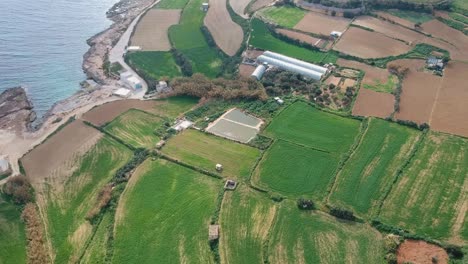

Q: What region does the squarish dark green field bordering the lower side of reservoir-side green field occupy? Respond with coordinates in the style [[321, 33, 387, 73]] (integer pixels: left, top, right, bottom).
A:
[[253, 140, 338, 198]]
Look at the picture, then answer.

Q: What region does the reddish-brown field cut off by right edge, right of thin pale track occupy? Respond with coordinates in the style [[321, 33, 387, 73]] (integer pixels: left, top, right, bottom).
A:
[[430, 62, 468, 137]]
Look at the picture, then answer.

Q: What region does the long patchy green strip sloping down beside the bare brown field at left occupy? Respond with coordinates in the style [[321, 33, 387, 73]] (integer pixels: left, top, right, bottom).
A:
[[47, 137, 131, 263]]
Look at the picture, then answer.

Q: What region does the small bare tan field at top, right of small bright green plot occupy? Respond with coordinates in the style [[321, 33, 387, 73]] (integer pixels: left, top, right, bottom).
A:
[[294, 12, 351, 36]]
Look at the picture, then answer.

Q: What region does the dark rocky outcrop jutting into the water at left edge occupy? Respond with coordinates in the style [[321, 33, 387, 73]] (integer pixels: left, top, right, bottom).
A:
[[0, 87, 36, 132]]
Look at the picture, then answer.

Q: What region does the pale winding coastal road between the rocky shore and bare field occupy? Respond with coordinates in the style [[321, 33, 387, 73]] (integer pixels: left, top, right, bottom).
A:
[[109, 0, 161, 99]]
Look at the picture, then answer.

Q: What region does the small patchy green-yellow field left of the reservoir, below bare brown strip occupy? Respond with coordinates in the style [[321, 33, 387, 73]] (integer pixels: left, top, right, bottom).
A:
[[104, 109, 163, 148]]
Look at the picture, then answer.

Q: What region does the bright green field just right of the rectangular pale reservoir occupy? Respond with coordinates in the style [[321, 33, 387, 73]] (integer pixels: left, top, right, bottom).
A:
[[265, 102, 360, 154]]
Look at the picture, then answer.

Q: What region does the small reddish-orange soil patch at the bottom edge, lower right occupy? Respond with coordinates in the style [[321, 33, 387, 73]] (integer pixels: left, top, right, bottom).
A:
[[397, 240, 448, 264]]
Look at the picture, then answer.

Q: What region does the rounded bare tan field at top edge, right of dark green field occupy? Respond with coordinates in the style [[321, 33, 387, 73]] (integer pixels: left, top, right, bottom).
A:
[[205, 0, 244, 56]]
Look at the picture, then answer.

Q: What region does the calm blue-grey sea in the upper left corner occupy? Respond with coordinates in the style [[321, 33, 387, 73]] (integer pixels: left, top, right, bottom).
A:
[[0, 0, 118, 117]]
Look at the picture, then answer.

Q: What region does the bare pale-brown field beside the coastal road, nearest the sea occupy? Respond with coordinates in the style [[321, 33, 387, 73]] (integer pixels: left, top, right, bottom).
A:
[[130, 9, 180, 51]]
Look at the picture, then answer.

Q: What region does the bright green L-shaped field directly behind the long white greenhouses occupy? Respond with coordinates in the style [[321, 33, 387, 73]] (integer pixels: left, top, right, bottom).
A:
[[249, 18, 338, 63]]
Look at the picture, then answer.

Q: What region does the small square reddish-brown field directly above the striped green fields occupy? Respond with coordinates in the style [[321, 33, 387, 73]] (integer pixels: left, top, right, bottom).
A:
[[352, 88, 395, 118]]
